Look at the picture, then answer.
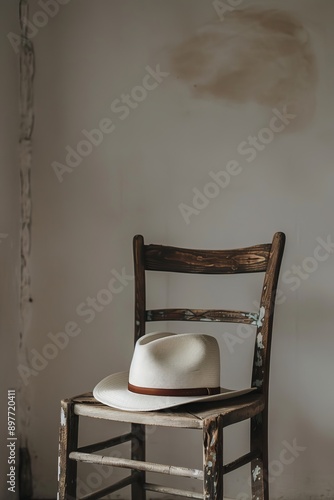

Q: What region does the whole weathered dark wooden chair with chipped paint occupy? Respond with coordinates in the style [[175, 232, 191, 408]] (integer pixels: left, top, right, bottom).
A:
[[58, 233, 285, 500]]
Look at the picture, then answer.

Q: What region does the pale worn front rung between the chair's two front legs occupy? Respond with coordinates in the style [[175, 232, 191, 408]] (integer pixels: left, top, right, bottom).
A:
[[70, 451, 203, 480]]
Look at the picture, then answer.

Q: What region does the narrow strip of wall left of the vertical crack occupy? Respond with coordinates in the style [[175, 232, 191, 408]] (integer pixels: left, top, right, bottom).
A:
[[0, 0, 20, 498]]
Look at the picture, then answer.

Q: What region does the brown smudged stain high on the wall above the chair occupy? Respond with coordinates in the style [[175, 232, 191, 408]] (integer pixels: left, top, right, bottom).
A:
[[171, 9, 317, 128]]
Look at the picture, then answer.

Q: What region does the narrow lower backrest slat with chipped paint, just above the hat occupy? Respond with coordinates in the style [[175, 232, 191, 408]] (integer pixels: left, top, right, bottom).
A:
[[146, 309, 259, 325]]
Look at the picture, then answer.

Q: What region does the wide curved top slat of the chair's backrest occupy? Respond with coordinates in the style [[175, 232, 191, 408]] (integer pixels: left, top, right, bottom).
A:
[[144, 244, 271, 274]]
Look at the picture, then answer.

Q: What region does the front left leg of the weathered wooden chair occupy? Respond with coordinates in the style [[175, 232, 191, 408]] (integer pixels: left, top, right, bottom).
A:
[[57, 400, 79, 500]]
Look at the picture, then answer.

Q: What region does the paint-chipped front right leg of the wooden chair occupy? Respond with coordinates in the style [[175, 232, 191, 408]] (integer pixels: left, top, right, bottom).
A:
[[203, 416, 224, 500]]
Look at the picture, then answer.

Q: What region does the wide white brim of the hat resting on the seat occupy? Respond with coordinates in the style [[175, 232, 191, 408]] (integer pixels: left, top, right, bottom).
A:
[[93, 372, 255, 411]]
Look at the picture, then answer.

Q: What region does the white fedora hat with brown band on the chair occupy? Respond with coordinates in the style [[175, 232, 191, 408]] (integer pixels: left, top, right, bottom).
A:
[[93, 332, 254, 411]]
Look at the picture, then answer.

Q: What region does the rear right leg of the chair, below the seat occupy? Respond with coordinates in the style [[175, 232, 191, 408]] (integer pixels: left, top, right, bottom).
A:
[[251, 411, 269, 500]]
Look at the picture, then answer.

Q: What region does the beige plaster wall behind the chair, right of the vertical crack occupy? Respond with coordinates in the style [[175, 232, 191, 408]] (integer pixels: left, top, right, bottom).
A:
[[26, 0, 334, 500]]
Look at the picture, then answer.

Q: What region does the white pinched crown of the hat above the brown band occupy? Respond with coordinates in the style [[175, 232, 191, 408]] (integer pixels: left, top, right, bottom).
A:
[[129, 332, 220, 389]]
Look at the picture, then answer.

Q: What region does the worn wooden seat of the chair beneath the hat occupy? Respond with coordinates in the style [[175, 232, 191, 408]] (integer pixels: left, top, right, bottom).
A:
[[72, 392, 265, 429]]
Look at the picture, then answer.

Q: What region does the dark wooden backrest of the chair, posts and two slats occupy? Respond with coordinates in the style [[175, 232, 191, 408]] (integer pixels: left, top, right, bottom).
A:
[[133, 233, 285, 396]]
